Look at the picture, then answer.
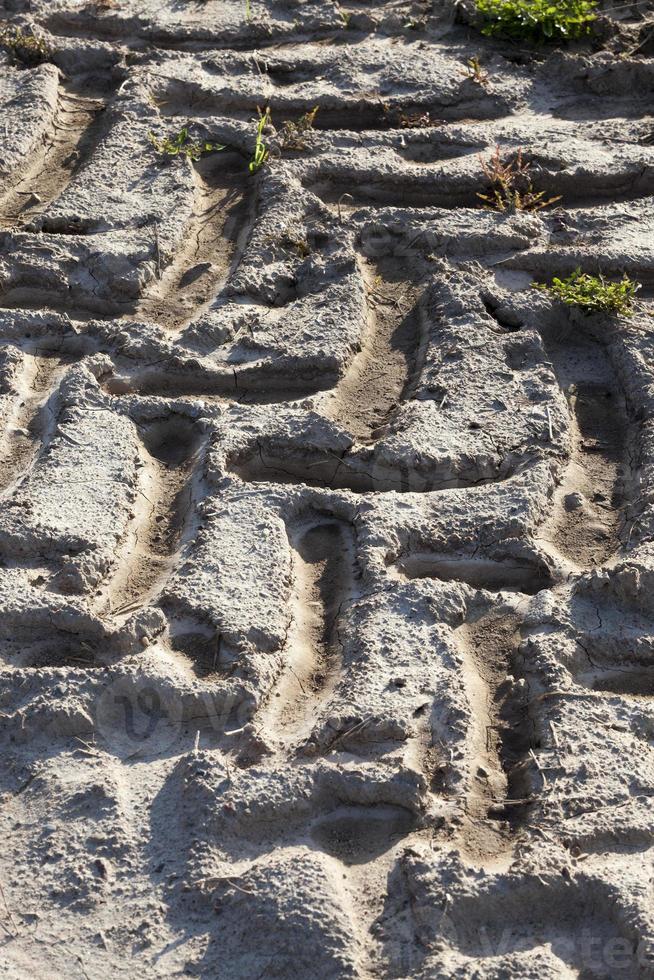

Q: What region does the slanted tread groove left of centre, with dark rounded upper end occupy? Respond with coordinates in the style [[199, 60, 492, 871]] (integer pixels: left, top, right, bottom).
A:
[[102, 414, 202, 619]]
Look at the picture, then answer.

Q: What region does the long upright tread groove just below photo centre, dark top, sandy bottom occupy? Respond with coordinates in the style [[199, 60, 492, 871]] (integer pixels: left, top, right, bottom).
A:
[[257, 517, 356, 753]]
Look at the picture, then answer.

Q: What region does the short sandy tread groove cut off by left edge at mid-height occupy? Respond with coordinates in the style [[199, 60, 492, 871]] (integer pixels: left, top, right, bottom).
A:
[[0, 353, 73, 496]]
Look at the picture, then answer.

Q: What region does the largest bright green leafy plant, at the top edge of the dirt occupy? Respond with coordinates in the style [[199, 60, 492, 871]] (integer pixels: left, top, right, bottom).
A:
[[475, 0, 597, 42]]
